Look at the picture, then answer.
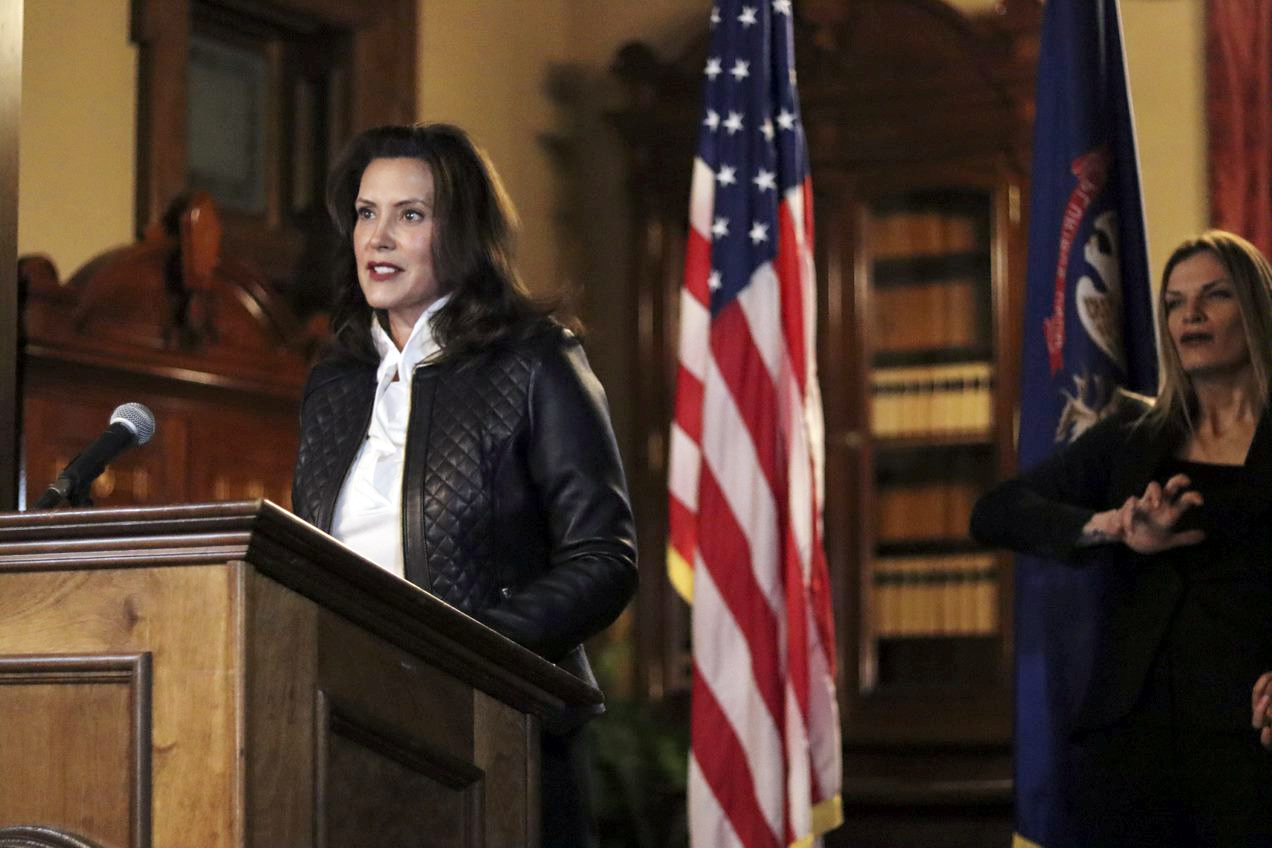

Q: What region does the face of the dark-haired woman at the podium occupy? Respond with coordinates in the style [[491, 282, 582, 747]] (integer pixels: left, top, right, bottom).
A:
[[354, 158, 441, 348]]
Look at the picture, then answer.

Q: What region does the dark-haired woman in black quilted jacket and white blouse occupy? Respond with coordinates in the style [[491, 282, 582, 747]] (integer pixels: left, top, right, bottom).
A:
[[293, 125, 636, 845]]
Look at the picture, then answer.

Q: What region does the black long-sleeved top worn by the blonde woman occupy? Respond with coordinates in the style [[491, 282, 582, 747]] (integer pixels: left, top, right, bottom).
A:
[[972, 399, 1272, 730]]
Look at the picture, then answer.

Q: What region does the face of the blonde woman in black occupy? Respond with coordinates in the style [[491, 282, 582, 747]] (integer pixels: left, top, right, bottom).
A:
[[1163, 250, 1250, 378]]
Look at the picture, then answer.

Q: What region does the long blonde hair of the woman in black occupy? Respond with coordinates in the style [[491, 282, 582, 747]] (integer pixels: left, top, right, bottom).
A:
[[1146, 230, 1272, 430]]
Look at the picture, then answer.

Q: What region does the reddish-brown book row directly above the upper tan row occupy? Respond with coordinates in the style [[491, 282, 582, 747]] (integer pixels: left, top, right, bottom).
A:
[[871, 278, 988, 353]]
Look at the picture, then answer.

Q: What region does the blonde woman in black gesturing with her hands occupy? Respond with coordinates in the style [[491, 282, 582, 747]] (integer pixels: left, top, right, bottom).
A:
[[972, 230, 1272, 847]]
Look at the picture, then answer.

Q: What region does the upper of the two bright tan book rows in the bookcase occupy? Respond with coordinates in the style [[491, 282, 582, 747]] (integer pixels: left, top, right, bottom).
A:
[[870, 362, 993, 436]]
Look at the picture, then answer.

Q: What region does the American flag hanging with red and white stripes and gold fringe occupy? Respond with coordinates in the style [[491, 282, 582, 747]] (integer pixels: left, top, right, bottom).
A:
[[668, 0, 842, 848]]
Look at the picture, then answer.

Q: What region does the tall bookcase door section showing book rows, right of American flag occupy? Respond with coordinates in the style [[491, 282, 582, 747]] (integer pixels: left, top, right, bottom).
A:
[[818, 158, 1024, 757]]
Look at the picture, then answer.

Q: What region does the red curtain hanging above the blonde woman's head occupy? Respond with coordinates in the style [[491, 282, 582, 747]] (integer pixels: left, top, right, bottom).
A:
[[1206, 0, 1272, 256]]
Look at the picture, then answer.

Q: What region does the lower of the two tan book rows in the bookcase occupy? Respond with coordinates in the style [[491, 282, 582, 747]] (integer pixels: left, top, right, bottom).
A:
[[870, 553, 999, 637]]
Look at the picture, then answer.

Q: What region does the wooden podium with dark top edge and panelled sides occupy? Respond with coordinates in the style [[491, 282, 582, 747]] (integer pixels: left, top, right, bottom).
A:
[[0, 501, 600, 848]]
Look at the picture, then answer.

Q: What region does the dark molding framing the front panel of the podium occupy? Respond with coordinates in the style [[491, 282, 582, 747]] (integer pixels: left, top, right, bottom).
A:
[[0, 651, 151, 848]]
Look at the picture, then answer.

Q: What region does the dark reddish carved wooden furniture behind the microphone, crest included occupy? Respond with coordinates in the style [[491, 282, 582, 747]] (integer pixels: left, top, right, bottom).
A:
[[19, 193, 322, 505]]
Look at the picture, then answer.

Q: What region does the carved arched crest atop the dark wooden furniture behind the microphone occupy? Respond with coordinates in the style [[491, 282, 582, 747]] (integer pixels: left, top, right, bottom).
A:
[[18, 192, 321, 402]]
